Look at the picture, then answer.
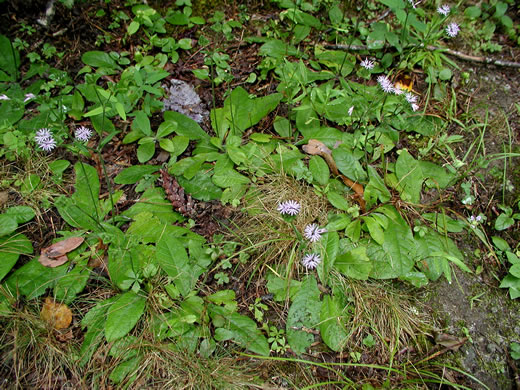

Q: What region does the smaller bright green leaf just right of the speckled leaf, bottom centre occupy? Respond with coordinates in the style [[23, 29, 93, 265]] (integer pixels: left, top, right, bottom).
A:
[[320, 295, 349, 352]]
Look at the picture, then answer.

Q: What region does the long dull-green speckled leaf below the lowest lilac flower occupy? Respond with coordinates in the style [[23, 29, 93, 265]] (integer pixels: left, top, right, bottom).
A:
[[286, 276, 321, 355]]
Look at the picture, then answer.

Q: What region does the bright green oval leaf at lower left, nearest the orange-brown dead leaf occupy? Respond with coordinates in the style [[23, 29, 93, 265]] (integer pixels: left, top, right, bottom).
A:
[[105, 291, 146, 342]]
